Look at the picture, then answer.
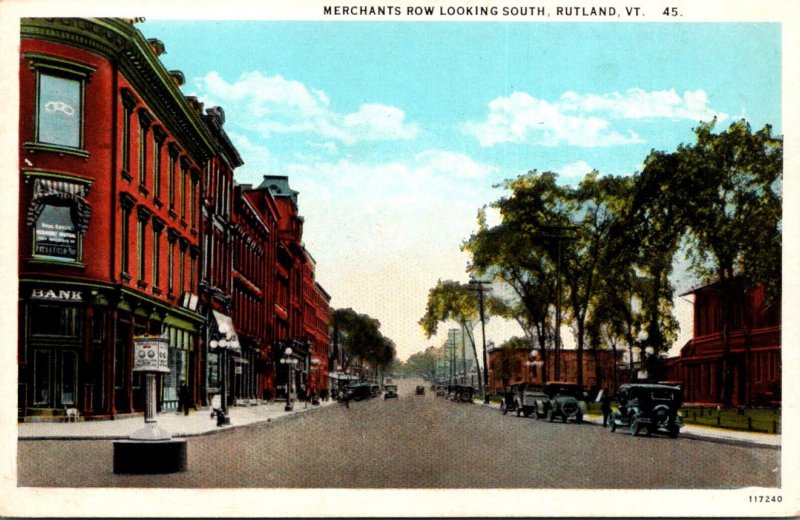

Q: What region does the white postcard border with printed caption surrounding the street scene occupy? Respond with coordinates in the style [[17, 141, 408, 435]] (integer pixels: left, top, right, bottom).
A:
[[0, 0, 800, 517]]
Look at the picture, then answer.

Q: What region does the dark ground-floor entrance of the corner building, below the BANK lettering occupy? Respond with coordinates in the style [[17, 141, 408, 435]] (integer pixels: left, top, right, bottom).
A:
[[32, 349, 78, 408]]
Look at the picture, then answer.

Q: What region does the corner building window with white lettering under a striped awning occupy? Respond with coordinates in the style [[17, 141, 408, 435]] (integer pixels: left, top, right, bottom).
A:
[[33, 204, 80, 262]]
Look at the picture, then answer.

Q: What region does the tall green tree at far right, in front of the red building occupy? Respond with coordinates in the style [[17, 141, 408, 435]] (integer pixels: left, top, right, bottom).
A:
[[677, 120, 783, 405]]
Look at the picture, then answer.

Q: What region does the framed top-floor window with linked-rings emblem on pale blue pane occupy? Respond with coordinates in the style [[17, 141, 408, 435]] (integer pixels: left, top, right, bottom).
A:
[[24, 53, 95, 156]]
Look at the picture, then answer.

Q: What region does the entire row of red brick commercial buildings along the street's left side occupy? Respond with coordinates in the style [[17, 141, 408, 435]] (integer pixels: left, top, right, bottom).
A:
[[18, 18, 330, 417]]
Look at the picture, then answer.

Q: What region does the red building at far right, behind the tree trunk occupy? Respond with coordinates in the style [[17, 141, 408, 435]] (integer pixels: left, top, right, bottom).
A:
[[666, 284, 781, 406]]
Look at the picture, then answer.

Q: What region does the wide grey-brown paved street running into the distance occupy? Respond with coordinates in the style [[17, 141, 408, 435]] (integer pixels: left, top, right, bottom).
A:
[[18, 381, 780, 489]]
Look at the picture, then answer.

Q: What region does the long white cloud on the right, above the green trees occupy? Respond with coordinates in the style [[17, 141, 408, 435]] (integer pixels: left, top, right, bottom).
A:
[[465, 88, 728, 147]]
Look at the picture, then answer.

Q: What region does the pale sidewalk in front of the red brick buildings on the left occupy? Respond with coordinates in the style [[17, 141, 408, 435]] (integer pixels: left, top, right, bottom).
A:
[[17, 400, 337, 440]]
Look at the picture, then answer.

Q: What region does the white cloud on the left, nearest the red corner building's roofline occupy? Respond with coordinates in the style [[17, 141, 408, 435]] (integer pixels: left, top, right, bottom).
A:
[[197, 71, 419, 145]]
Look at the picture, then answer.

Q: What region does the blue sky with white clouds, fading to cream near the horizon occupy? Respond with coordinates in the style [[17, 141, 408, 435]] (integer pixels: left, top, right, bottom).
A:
[[137, 18, 782, 359]]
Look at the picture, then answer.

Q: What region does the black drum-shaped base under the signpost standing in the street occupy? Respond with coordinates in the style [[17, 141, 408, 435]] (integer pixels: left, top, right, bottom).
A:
[[114, 439, 186, 475]]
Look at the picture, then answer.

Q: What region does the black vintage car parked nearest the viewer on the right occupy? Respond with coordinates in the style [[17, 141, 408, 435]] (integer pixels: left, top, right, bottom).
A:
[[608, 383, 683, 439]]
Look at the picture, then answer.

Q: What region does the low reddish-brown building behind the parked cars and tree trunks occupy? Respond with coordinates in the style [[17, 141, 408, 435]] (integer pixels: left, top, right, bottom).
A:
[[487, 348, 627, 393]]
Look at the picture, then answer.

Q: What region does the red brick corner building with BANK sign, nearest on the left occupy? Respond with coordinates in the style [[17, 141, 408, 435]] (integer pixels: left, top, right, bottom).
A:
[[18, 18, 214, 416]]
